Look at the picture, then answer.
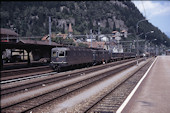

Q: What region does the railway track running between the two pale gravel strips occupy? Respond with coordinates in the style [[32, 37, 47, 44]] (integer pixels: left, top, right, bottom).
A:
[[1, 59, 143, 112]]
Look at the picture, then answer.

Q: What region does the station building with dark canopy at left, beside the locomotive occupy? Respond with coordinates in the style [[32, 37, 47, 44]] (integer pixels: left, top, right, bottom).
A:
[[0, 28, 59, 67]]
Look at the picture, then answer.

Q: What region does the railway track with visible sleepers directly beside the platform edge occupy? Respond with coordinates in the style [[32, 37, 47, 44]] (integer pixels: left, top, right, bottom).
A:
[[81, 57, 153, 113]]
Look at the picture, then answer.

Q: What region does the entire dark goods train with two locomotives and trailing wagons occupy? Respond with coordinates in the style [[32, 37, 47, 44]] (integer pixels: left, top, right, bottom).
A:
[[50, 47, 136, 72]]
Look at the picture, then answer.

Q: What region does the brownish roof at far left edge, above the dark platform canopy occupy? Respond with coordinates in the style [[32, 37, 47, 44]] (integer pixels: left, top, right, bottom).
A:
[[0, 28, 19, 36]]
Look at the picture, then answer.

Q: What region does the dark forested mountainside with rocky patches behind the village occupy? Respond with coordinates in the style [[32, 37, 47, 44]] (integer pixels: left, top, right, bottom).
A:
[[0, 1, 170, 47]]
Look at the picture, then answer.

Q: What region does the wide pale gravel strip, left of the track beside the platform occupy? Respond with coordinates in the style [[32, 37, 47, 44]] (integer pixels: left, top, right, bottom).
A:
[[30, 61, 149, 113]]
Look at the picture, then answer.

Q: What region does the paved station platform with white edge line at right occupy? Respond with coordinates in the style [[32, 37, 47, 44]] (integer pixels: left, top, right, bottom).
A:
[[116, 56, 170, 113]]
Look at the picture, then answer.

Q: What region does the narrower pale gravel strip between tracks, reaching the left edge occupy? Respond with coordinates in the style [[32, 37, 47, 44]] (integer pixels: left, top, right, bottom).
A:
[[1, 60, 135, 107]]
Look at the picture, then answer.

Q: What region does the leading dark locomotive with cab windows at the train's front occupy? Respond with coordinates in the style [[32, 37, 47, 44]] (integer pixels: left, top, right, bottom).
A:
[[50, 47, 93, 71]]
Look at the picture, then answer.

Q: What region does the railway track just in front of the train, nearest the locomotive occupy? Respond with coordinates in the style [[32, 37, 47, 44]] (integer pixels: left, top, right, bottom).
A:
[[1, 59, 133, 96]]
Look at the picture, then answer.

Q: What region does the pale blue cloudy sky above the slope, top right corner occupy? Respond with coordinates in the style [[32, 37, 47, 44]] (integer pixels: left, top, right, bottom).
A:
[[133, 0, 170, 37]]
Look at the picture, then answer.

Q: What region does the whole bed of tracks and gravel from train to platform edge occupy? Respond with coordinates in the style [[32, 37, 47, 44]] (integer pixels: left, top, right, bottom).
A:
[[1, 56, 169, 113]]
